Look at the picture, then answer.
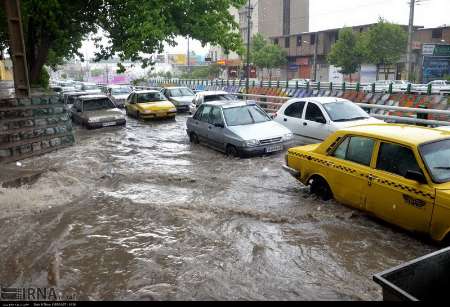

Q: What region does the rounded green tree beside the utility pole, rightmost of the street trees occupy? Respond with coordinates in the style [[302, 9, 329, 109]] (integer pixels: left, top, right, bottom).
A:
[[361, 18, 408, 79]]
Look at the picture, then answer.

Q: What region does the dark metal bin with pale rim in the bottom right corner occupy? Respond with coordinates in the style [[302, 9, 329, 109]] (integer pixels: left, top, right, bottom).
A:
[[373, 248, 450, 301]]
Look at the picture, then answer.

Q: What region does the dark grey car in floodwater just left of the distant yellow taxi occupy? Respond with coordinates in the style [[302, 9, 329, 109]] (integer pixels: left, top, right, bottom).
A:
[[70, 95, 126, 129]]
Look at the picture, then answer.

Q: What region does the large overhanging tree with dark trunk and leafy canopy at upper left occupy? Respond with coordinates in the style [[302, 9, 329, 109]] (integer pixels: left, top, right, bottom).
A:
[[0, 0, 245, 83]]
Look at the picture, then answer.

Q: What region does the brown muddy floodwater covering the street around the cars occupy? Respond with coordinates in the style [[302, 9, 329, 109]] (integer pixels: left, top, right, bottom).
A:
[[0, 116, 438, 300]]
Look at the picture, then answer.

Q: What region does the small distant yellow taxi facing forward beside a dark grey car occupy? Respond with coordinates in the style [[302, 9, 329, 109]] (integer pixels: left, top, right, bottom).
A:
[[125, 90, 177, 119]]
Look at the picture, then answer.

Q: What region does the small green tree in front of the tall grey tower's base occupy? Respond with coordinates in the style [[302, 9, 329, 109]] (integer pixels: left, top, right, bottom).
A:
[[250, 34, 287, 80]]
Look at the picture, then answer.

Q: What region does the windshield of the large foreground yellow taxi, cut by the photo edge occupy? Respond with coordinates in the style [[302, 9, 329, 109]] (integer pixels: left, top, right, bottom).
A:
[[420, 140, 450, 183]]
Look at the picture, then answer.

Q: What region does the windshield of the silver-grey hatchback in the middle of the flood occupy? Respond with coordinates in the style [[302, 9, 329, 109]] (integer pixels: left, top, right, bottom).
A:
[[223, 105, 271, 127]]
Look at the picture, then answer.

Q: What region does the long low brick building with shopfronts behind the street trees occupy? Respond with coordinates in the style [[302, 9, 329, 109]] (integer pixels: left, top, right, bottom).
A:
[[271, 24, 450, 82]]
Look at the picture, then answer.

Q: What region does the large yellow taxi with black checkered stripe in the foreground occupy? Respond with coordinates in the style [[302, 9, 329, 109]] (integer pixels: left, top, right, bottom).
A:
[[284, 124, 450, 241]]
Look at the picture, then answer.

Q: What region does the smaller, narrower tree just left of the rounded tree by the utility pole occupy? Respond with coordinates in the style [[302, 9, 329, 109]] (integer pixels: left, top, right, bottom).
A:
[[328, 28, 364, 82]]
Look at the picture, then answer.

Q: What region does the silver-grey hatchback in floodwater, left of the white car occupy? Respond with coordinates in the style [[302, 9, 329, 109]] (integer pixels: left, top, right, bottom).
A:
[[187, 101, 292, 157]]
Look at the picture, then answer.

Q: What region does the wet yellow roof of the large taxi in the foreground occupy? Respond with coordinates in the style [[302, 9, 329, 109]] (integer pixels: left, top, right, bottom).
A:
[[341, 124, 450, 146]]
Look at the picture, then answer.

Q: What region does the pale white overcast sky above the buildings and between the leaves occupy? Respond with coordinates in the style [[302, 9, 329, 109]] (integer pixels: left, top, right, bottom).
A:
[[81, 0, 450, 57]]
